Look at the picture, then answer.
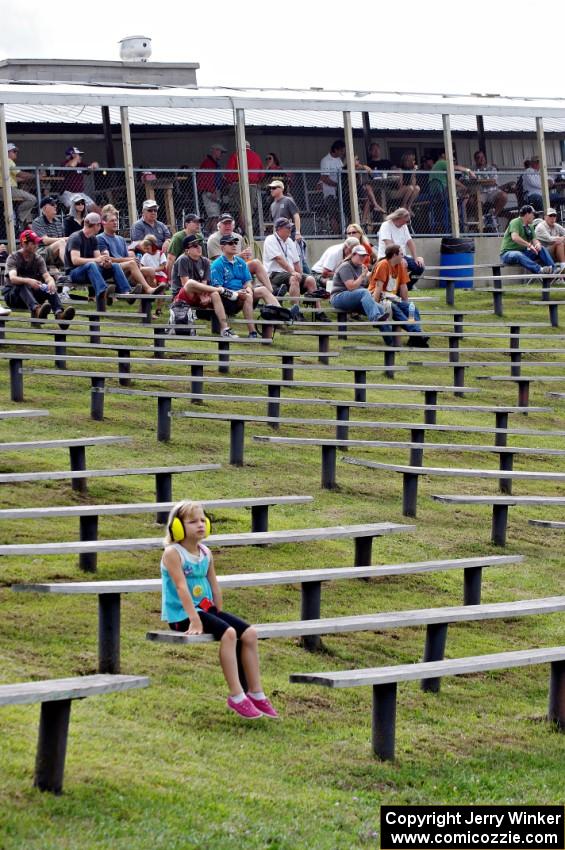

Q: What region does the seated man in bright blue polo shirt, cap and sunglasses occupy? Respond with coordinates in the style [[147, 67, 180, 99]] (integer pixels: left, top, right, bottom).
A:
[[210, 233, 280, 338]]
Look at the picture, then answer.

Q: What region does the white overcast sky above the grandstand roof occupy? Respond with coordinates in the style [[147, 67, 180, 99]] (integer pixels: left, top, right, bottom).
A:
[[0, 0, 565, 97]]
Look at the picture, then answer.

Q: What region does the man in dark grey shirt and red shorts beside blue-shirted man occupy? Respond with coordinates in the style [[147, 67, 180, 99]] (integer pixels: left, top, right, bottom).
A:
[[172, 233, 238, 339]]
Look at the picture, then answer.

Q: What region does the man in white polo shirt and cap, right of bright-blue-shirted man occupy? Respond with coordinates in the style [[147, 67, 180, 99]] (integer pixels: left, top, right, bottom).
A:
[[263, 218, 329, 322]]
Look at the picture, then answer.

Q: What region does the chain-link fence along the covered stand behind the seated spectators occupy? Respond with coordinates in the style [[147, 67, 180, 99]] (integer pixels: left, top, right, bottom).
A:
[[1, 166, 565, 239]]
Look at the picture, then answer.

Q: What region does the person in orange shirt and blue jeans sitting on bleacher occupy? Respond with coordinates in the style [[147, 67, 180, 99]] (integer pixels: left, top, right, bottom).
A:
[[368, 240, 430, 348]]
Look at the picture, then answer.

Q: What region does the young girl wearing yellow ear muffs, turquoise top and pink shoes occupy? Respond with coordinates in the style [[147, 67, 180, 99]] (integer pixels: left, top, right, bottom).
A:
[[161, 501, 278, 720]]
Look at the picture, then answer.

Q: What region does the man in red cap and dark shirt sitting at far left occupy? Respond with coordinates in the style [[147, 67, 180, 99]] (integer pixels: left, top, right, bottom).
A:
[[3, 230, 75, 330]]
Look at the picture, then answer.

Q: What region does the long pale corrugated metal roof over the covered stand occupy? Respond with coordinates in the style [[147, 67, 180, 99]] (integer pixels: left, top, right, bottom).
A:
[[0, 82, 565, 133]]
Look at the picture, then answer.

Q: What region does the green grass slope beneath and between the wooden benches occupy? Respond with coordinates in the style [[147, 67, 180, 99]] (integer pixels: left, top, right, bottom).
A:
[[0, 292, 565, 850]]
